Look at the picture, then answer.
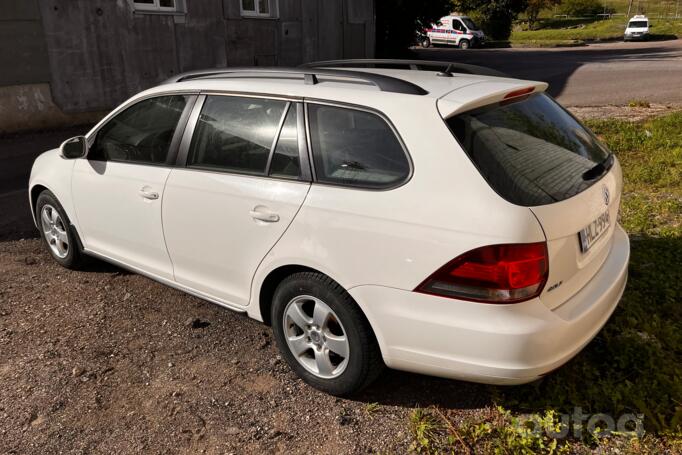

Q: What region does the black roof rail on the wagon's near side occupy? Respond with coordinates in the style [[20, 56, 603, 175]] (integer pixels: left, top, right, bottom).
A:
[[163, 67, 428, 95]]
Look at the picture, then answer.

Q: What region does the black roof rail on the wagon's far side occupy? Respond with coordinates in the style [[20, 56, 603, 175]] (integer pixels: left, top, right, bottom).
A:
[[300, 58, 509, 77]]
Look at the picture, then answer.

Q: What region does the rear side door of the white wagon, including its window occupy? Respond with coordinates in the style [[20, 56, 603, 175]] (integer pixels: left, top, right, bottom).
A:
[[163, 95, 310, 305]]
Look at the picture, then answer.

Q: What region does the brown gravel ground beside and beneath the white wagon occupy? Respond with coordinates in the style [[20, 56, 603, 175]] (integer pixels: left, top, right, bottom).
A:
[[0, 239, 490, 454]]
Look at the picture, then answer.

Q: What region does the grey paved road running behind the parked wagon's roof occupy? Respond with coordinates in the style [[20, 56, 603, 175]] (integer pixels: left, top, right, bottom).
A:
[[417, 40, 682, 106]]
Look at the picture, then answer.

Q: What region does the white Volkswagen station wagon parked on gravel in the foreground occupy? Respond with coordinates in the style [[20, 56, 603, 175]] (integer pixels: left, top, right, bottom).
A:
[[29, 60, 630, 395]]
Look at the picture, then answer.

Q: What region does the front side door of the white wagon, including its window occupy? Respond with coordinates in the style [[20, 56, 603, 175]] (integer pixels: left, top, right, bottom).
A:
[[71, 95, 196, 279]]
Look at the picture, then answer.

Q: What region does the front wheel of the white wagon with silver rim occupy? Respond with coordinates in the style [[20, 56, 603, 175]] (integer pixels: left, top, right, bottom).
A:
[[35, 190, 85, 270]]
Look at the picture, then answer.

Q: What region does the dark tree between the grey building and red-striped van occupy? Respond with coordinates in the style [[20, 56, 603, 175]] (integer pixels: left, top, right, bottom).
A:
[[376, 0, 452, 58]]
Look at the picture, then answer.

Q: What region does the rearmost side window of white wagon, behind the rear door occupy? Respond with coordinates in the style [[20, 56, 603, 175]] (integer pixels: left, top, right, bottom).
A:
[[308, 104, 410, 189]]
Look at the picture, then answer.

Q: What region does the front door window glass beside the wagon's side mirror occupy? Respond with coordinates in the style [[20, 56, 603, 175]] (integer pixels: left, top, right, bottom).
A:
[[88, 95, 187, 164]]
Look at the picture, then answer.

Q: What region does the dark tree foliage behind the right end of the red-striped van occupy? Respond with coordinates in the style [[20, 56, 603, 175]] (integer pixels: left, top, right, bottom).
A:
[[454, 0, 528, 40]]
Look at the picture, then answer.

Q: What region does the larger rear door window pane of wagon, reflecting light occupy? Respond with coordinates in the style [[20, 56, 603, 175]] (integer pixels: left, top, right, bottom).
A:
[[187, 96, 287, 174]]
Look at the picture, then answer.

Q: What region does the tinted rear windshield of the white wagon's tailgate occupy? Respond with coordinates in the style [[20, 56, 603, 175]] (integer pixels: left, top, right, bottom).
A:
[[447, 93, 613, 206]]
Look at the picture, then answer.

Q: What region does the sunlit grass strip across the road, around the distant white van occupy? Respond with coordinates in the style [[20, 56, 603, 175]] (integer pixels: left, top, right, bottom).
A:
[[511, 17, 682, 47]]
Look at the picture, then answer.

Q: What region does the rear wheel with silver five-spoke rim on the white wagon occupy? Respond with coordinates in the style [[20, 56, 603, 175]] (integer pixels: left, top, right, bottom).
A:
[[271, 272, 384, 396]]
